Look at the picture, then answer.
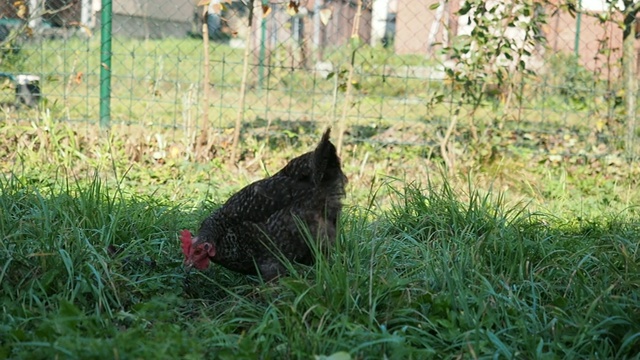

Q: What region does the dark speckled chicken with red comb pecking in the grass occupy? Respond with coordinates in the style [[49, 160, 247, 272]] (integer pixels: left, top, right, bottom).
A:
[[182, 129, 347, 280]]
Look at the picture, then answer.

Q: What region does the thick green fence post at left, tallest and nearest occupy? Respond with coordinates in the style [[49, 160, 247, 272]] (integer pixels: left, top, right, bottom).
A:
[[100, 0, 113, 128]]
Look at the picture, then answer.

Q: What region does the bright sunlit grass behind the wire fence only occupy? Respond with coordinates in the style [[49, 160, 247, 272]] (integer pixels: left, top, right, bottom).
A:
[[0, 34, 623, 136]]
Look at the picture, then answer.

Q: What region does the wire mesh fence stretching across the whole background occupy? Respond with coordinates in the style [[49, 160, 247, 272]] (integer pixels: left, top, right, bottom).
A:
[[0, 0, 638, 160]]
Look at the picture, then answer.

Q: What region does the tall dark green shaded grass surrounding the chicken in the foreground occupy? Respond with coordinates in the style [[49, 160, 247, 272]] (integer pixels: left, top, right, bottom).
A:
[[0, 174, 640, 359]]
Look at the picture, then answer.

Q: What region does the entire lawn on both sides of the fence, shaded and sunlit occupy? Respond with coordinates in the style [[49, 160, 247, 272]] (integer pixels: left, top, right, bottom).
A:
[[0, 32, 640, 360]]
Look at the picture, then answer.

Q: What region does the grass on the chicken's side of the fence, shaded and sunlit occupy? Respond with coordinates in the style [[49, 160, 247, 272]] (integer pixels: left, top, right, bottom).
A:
[[0, 120, 640, 359]]
